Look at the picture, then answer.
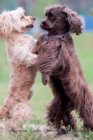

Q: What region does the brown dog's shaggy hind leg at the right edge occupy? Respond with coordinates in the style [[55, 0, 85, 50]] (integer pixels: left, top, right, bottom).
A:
[[79, 86, 93, 131]]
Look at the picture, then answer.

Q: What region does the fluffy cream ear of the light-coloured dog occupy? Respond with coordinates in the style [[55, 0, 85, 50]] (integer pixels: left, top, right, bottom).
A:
[[0, 12, 13, 35]]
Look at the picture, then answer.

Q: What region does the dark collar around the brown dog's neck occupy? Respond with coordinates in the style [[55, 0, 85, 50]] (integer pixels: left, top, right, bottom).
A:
[[43, 33, 68, 42]]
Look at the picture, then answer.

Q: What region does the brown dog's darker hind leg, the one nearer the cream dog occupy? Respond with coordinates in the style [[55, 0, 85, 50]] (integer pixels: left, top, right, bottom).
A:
[[46, 76, 77, 131]]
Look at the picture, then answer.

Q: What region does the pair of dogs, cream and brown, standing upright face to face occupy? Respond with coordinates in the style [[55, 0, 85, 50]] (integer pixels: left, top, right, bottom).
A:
[[0, 5, 93, 131]]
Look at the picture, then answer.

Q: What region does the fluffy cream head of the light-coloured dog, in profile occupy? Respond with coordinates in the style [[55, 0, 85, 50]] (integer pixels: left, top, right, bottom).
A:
[[0, 8, 35, 35]]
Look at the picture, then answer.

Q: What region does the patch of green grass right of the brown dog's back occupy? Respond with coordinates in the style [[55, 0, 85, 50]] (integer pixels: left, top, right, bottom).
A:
[[73, 33, 93, 83]]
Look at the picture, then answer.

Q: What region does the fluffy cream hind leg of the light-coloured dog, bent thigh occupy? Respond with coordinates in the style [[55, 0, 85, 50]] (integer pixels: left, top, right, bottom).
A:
[[5, 102, 31, 131]]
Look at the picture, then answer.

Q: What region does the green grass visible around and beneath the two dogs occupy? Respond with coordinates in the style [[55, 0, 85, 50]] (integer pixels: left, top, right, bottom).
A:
[[0, 33, 93, 140]]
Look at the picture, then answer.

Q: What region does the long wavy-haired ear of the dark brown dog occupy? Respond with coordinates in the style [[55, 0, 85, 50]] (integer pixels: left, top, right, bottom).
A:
[[62, 5, 83, 35]]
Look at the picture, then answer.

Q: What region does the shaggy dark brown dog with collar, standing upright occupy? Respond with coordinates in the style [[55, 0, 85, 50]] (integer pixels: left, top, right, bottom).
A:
[[33, 5, 93, 132]]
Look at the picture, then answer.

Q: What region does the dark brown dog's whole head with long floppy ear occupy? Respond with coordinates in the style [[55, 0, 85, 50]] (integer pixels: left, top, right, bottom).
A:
[[40, 5, 82, 35]]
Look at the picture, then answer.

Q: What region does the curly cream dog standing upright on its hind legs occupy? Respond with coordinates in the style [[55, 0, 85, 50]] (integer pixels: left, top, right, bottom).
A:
[[0, 7, 37, 130]]
